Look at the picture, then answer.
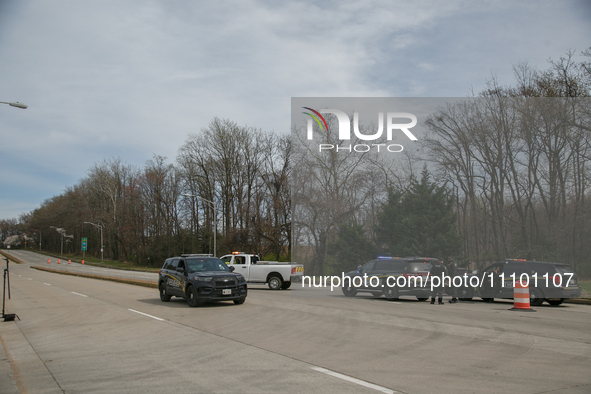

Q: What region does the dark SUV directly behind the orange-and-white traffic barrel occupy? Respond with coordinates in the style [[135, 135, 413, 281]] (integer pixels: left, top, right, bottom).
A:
[[464, 259, 581, 306]]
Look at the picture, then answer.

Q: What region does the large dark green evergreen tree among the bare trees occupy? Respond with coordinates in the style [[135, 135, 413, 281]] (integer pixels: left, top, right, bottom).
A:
[[376, 169, 461, 259]]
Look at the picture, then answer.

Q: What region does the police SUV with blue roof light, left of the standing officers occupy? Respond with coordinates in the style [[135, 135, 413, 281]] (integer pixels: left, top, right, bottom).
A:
[[341, 256, 434, 301]]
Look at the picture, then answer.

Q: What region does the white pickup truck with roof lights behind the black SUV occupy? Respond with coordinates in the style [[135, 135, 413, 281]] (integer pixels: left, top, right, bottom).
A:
[[221, 253, 304, 290]]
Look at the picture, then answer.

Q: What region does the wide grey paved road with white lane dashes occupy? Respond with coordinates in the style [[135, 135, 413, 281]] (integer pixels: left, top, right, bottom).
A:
[[0, 251, 591, 394]]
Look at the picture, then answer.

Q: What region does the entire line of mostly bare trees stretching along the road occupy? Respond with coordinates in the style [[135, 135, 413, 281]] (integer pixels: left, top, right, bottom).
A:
[[0, 49, 591, 275]]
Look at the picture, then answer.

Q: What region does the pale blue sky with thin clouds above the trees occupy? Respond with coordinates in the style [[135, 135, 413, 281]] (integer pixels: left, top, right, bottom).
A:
[[0, 0, 591, 219]]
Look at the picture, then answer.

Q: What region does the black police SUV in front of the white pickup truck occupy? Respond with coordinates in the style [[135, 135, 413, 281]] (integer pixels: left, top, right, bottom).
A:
[[158, 255, 247, 307]]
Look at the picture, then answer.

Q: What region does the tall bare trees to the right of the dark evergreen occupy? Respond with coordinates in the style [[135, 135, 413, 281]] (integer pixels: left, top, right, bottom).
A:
[[425, 49, 591, 275]]
